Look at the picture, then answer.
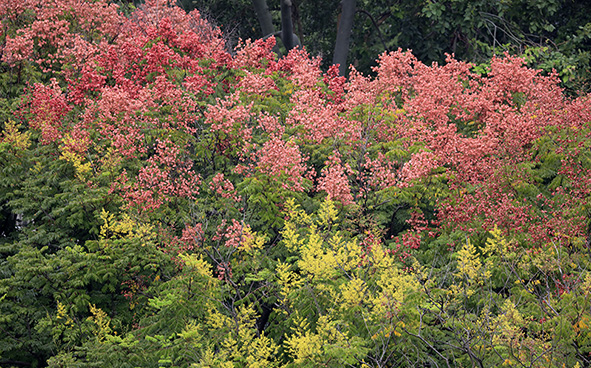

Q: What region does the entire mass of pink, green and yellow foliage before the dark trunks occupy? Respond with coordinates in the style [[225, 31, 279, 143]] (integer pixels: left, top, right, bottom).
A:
[[0, 0, 591, 367]]
